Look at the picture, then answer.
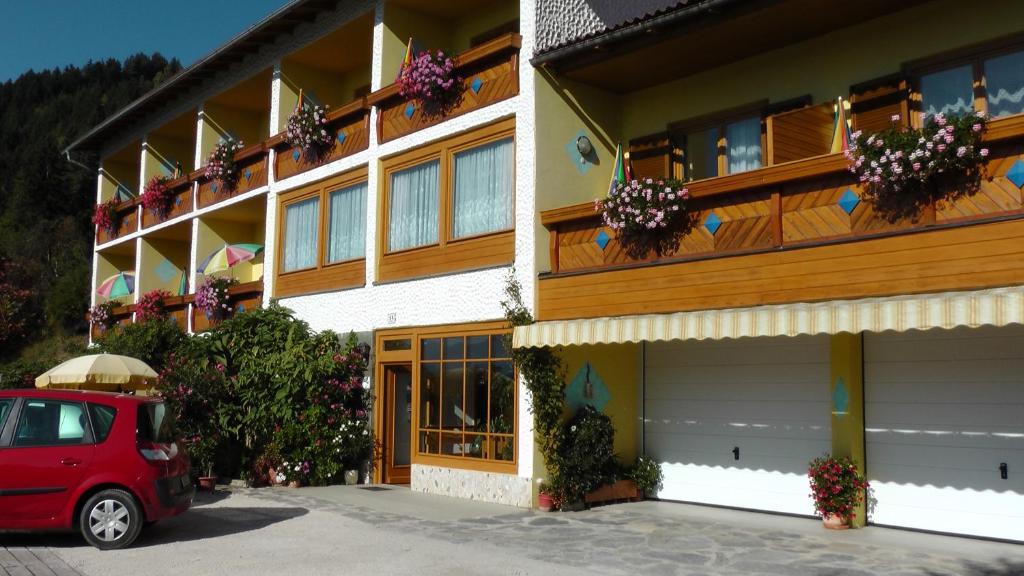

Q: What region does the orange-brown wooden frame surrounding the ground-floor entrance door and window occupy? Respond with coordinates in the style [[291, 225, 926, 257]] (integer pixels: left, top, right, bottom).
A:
[[374, 321, 519, 475]]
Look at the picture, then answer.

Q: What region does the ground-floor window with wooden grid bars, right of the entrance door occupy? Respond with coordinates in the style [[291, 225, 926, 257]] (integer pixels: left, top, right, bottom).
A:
[[417, 333, 516, 463]]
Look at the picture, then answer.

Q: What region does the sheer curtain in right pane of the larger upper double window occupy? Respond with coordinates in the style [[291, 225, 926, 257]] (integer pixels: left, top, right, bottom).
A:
[[452, 138, 515, 238]]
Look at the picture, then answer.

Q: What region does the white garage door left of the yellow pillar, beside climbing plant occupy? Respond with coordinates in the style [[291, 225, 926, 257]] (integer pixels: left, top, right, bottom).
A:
[[644, 336, 831, 515]]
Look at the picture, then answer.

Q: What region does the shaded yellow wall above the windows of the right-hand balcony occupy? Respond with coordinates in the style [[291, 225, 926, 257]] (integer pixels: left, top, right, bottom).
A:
[[614, 0, 1024, 139]]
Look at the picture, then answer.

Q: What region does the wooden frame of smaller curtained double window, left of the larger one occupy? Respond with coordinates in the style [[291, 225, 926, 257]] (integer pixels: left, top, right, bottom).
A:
[[273, 166, 369, 297]]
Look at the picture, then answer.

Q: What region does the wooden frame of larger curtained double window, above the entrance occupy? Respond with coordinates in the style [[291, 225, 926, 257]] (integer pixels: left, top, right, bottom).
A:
[[377, 118, 516, 282]]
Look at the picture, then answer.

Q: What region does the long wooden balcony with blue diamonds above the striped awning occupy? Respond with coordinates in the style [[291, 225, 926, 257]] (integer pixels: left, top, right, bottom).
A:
[[539, 116, 1024, 320]]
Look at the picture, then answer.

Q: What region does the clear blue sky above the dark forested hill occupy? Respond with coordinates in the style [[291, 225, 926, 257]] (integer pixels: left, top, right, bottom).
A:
[[0, 0, 288, 82]]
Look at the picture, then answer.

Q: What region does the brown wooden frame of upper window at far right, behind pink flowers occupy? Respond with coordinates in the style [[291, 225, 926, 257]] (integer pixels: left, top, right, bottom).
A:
[[903, 34, 1024, 128]]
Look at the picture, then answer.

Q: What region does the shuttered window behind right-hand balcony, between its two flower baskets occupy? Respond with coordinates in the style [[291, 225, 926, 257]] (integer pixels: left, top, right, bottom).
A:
[[675, 115, 763, 180]]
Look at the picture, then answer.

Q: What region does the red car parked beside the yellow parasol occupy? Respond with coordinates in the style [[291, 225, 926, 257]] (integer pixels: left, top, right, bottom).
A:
[[0, 389, 195, 549]]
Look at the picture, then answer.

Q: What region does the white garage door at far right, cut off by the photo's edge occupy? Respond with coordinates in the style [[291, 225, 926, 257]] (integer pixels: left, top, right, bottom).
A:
[[864, 326, 1024, 540]]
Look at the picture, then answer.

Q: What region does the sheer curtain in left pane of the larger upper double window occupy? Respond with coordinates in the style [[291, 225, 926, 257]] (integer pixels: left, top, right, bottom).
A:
[[387, 160, 439, 252]]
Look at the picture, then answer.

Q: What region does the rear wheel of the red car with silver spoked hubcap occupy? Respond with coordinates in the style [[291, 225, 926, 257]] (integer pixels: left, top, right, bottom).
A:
[[79, 489, 144, 550]]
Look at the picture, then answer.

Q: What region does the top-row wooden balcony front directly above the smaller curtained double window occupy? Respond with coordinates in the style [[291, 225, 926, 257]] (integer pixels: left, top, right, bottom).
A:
[[266, 97, 370, 180]]
